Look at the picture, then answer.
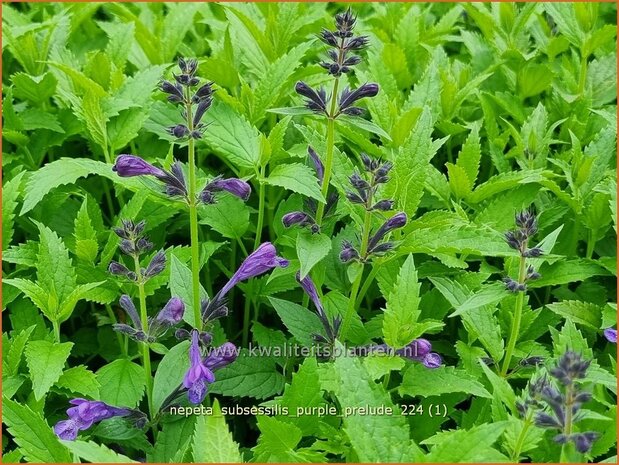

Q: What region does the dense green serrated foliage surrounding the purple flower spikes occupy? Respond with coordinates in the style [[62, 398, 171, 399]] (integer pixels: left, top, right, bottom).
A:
[[2, 3, 617, 462]]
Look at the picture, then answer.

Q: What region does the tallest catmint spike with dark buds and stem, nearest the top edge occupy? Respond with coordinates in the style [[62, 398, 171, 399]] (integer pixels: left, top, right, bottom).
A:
[[295, 8, 379, 227]]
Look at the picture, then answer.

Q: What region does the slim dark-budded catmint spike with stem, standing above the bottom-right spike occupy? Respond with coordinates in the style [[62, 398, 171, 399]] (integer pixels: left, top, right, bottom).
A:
[[501, 210, 542, 376]]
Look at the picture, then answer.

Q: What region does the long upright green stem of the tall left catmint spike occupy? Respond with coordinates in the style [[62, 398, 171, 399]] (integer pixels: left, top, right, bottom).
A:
[[185, 89, 202, 331]]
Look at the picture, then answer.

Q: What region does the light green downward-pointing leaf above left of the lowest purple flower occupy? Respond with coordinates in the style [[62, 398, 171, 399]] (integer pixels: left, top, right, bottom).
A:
[[25, 340, 73, 400]]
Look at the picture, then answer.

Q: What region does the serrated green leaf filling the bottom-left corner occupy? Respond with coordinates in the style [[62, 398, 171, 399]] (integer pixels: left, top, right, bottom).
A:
[[2, 397, 72, 463]]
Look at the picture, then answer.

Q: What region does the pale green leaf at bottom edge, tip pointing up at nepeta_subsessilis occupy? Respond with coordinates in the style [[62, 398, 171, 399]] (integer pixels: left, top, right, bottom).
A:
[[192, 399, 243, 463]]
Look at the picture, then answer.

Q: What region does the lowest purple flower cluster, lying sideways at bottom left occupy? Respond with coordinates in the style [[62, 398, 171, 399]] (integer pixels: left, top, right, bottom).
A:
[[54, 399, 131, 441]]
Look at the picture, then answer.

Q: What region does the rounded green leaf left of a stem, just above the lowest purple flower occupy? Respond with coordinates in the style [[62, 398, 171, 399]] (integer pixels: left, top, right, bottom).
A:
[[97, 359, 145, 408]]
